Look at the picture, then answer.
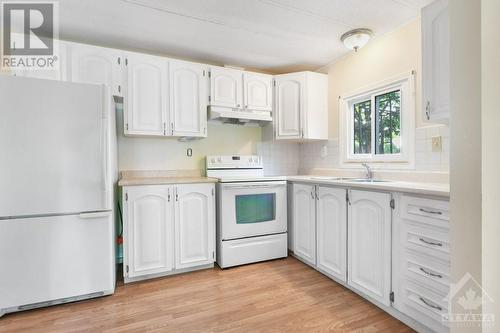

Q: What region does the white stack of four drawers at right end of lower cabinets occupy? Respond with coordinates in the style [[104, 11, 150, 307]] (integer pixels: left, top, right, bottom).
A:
[[393, 195, 450, 332]]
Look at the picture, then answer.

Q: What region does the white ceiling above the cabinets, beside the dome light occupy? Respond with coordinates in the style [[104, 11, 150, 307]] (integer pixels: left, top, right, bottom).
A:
[[59, 0, 429, 73]]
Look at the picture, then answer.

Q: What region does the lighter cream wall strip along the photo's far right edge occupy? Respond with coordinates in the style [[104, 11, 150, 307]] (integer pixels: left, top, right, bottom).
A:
[[481, 0, 500, 332]]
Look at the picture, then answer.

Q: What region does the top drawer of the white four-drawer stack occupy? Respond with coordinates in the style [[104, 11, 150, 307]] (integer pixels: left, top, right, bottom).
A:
[[401, 195, 450, 229]]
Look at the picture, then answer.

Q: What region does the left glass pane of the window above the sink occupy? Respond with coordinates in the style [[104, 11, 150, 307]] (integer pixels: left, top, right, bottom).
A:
[[353, 100, 372, 154]]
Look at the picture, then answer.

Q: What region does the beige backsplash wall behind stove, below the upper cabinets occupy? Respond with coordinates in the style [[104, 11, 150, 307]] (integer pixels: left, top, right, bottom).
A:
[[117, 104, 261, 170]]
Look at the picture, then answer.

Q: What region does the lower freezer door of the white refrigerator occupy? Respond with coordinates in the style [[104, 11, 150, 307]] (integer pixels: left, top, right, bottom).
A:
[[0, 211, 115, 314]]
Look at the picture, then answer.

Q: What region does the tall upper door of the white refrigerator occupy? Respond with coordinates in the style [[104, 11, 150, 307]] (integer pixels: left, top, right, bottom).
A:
[[0, 76, 110, 218]]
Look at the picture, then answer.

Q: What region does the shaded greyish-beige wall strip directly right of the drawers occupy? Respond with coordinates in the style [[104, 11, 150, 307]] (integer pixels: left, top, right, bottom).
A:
[[450, 0, 482, 332]]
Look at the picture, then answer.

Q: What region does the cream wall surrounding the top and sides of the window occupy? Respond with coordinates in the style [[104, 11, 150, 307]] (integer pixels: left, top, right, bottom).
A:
[[325, 18, 424, 138]]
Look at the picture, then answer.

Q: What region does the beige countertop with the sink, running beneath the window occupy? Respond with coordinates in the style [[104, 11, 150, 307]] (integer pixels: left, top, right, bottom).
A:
[[287, 175, 450, 198]]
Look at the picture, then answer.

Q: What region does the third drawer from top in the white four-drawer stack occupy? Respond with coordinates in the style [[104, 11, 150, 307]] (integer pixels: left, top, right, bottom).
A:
[[402, 251, 450, 294]]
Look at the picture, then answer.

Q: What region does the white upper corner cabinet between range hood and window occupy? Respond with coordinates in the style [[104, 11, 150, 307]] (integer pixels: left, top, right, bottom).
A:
[[274, 72, 328, 141]]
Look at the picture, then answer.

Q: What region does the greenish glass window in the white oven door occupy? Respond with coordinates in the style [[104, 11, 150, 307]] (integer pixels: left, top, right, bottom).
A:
[[235, 193, 276, 224]]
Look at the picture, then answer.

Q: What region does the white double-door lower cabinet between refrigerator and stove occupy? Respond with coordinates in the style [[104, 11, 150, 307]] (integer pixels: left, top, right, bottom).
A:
[[122, 184, 215, 282]]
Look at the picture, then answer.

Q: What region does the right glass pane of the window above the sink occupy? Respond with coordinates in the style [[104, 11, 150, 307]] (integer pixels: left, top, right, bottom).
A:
[[375, 90, 401, 154]]
